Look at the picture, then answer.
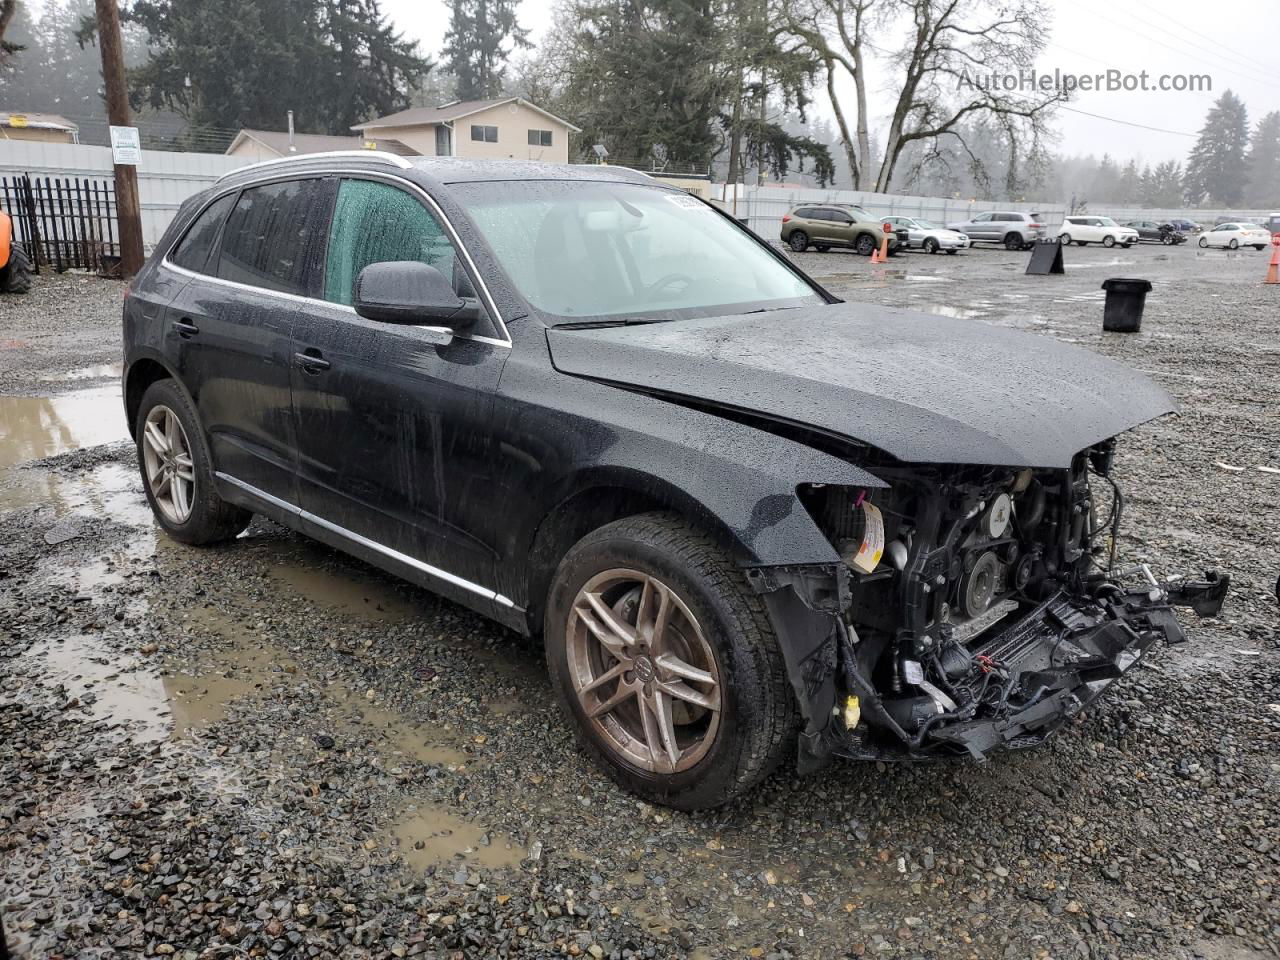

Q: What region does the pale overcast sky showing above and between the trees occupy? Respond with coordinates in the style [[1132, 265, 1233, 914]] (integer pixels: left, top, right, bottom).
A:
[[381, 0, 1280, 161]]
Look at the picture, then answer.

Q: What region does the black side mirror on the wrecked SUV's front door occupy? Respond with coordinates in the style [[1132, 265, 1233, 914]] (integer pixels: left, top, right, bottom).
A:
[[353, 260, 480, 330]]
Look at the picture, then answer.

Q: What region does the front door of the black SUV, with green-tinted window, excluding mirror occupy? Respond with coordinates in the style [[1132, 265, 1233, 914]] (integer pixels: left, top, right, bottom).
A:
[[291, 171, 509, 594]]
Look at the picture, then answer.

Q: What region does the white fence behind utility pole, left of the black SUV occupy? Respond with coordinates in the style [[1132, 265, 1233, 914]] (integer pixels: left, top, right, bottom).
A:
[[0, 140, 250, 250]]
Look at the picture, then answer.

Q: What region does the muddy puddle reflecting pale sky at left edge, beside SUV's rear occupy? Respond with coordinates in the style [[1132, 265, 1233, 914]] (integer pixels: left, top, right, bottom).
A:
[[0, 383, 129, 467]]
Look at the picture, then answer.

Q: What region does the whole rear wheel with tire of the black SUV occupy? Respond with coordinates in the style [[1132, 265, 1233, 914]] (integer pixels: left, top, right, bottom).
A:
[[134, 380, 253, 545]]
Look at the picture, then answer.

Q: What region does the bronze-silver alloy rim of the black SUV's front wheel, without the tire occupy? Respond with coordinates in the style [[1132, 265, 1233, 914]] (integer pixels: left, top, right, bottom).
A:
[[566, 568, 723, 774]]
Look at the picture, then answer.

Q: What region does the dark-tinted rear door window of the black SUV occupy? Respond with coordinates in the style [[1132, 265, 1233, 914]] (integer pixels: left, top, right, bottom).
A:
[[218, 180, 323, 296]]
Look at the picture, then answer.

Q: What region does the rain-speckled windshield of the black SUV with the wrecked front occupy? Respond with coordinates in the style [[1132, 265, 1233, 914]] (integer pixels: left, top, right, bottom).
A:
[[454, 180, 824, 320]]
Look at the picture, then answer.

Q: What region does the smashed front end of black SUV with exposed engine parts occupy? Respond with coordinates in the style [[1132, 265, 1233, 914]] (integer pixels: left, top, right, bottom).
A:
[[749, 440, 1229, 771]]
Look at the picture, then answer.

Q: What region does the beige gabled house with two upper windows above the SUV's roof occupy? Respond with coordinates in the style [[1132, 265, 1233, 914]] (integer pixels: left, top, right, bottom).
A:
[[352, 97, 580, 164]]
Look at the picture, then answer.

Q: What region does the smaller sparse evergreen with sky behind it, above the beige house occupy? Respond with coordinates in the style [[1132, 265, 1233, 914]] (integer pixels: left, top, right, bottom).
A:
[[443, 0, 532, 100]]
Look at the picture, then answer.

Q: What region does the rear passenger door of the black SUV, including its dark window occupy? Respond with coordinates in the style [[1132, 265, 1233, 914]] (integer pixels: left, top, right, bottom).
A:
[[168, 179, 323, 503]]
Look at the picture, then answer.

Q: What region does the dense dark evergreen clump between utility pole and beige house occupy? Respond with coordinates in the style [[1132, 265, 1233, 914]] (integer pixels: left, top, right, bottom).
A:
[[128, 0, 431, 134]]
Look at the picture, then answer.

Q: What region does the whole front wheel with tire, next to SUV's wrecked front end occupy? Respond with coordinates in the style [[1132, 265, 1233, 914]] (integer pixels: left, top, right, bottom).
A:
[[544, 513, 799, 810]]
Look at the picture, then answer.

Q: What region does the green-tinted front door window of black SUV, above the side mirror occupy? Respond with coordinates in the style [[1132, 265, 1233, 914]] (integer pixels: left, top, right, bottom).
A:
[[324, 180, 454, 306]]
